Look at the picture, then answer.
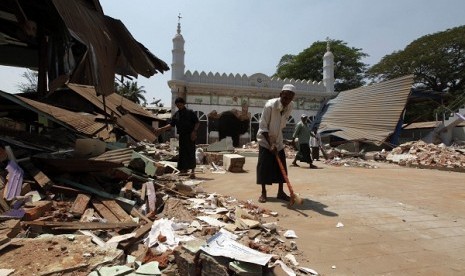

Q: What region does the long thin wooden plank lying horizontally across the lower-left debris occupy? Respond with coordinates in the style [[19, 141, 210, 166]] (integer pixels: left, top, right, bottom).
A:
[[22, 221, 139, 230]]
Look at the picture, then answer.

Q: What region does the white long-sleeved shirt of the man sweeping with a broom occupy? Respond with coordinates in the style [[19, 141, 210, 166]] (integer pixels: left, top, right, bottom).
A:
[[257, 98, 294, 151]]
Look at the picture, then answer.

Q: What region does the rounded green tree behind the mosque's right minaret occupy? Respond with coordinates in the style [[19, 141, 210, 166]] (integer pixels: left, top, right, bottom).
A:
[[274, 40, 368, 91]]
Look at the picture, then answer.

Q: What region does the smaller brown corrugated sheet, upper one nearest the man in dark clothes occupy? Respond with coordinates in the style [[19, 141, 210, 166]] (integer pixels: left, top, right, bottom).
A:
[[67, 83, 156, 119]]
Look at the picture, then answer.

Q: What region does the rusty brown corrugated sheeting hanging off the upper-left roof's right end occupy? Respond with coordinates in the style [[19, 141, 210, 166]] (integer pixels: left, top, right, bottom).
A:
[[52, 0, 169, 95]]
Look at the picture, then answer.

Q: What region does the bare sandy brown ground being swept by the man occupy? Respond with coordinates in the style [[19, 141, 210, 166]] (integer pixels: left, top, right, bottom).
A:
[[198, 157, 465, 275]]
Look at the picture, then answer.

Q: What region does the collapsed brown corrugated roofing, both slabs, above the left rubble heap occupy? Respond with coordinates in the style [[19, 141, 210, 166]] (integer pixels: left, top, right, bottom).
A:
[[0, 84, 157, 142]]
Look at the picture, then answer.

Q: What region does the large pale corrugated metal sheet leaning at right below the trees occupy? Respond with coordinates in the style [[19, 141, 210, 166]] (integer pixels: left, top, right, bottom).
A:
[[318, 75, 413, 145]]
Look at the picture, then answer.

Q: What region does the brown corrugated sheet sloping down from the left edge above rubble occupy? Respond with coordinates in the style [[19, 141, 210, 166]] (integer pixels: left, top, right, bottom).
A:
[[0, 91, 105, 136]]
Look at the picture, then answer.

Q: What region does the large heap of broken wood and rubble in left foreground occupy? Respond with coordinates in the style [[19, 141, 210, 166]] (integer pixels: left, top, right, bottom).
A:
[[0, 139, 316, 275]]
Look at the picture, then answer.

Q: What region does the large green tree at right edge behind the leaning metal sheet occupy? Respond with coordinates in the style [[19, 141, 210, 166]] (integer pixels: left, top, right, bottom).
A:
[[367, 26, 465, 121]]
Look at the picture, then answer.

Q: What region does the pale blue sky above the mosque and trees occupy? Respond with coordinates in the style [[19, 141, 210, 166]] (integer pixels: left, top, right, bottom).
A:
[[0, 0, 465, 106]]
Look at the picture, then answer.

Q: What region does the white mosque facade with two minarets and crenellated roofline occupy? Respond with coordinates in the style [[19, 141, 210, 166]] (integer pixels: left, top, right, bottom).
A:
[[168, 22, 337, 146]]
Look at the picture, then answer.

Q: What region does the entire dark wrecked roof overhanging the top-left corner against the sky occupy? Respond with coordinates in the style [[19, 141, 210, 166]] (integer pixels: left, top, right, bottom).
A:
[[0, 0, 169, 96]]
